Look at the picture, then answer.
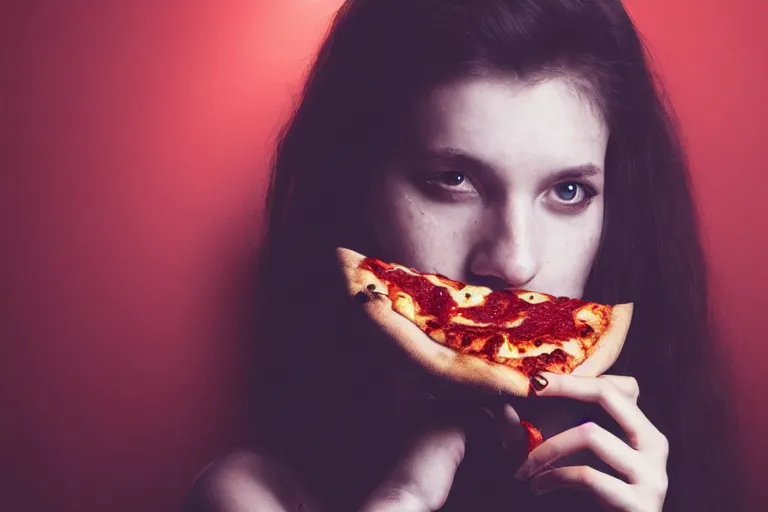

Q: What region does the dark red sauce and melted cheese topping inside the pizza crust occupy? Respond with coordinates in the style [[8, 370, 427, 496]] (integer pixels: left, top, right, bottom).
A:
[[360, 254, 600, 376]]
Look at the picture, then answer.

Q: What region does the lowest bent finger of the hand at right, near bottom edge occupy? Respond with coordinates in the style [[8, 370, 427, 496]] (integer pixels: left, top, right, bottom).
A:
[[530, 466, 637, 510]]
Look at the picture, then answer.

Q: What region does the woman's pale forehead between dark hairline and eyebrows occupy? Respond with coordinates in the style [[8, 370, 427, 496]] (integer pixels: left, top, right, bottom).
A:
[[404, 77, 608, 180]]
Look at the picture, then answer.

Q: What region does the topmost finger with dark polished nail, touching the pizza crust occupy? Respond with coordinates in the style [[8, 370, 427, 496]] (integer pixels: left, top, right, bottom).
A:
[[536, 372, 668, 457]]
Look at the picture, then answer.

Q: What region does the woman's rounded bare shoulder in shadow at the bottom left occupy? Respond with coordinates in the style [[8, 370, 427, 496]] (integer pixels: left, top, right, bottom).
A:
[[183, 449, 318, 512]]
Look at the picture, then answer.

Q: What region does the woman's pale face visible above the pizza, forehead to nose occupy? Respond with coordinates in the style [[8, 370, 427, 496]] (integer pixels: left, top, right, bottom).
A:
[[370, 78, 608, 297]]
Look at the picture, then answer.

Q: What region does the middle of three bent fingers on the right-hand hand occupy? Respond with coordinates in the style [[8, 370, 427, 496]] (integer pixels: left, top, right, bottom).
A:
[[515, 422, 640, 483]]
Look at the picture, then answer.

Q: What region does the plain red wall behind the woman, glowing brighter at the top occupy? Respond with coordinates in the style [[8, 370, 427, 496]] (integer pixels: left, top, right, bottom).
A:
[[0, 0, 768, 511]]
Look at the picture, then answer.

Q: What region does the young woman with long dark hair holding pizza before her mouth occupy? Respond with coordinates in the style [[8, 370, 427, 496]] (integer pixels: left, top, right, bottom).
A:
[[184, 0, 740, 511]]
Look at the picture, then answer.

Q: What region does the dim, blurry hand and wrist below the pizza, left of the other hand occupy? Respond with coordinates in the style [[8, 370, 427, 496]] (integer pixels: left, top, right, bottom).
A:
[[361, 427, 465, 512]]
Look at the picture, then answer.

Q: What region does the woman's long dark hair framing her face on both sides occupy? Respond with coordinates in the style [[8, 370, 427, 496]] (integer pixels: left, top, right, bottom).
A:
[[254, 0, 740, 510]]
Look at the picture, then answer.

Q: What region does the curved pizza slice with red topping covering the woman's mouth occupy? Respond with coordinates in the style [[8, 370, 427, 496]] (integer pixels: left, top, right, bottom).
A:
[[337, 248, 633, 396]]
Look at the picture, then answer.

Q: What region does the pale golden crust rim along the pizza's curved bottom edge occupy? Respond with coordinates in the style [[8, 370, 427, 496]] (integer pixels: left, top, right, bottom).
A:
[[337, 248, 632, 397]]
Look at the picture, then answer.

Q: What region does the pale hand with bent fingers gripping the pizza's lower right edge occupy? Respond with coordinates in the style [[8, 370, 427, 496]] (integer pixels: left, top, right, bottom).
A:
[[515, 373, 669, 512]]
